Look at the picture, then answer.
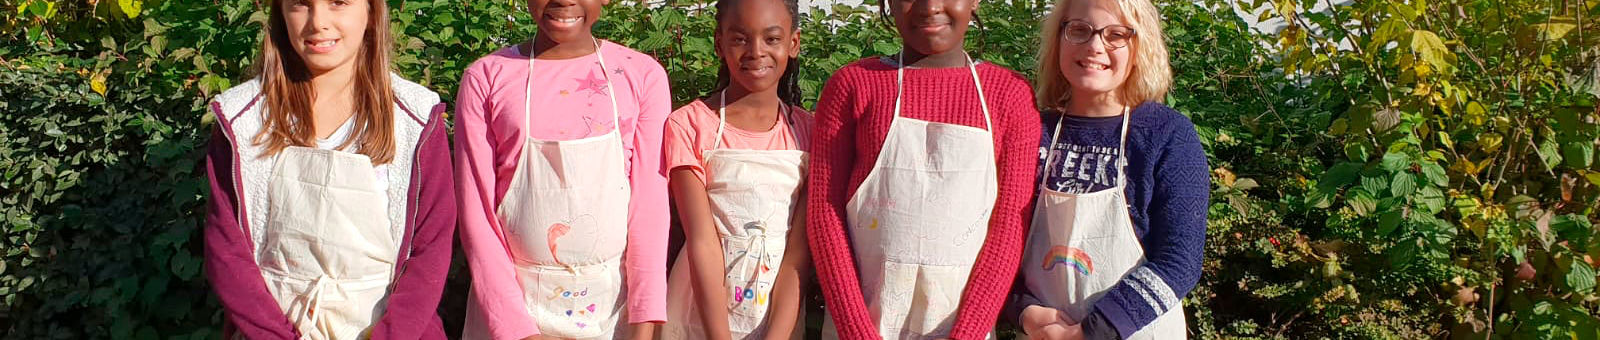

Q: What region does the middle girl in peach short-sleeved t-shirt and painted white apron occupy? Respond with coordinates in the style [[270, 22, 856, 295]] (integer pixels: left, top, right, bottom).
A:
[[662, 0, 811, 340]]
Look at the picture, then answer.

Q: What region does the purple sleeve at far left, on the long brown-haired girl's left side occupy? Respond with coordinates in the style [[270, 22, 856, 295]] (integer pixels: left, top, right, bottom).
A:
[[205, 103, 299, 338]]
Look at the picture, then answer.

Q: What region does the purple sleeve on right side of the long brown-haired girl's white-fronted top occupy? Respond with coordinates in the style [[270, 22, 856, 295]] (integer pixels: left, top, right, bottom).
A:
[[373, 103, 456, 338]]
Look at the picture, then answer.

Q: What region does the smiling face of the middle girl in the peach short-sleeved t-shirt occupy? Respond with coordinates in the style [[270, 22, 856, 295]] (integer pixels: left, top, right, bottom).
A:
[[717, 0, 800, 91]]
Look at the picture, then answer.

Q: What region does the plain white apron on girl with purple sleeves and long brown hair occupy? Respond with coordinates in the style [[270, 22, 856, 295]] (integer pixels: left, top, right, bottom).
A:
[[261, 146, 400, 340]]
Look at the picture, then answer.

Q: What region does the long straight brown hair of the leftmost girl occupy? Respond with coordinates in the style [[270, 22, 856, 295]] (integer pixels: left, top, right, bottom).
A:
[[251, 0, 395, 164]]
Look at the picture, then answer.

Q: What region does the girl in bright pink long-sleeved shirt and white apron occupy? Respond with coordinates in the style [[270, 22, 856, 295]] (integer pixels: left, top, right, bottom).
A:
[[456, 0, 672, 338]]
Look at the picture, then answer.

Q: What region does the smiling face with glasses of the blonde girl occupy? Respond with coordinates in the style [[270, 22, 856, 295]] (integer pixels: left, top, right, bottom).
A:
[[1058, 0, 1138, 98]]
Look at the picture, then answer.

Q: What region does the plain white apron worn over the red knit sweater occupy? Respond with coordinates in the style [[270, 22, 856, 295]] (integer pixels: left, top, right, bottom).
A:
[[824, 53, 998, 338]]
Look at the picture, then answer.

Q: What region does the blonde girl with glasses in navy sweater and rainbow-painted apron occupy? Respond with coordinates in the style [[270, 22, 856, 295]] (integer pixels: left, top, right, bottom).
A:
[[1005, 0, 1210, 338]]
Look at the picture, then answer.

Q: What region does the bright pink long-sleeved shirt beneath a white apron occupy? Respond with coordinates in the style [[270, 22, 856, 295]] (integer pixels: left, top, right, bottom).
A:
[[454, 42, 672, 338]]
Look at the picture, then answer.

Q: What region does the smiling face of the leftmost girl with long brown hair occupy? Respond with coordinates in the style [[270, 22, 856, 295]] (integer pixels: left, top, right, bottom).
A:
[[278, 0, 371, 75]]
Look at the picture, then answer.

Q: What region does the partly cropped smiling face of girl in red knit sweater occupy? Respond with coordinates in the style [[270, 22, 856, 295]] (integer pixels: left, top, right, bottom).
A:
[[883, 0, 978, 55]]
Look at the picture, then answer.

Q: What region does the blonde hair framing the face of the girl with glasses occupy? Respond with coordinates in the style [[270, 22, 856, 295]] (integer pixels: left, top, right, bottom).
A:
[[1034, 0, 1173, 107]]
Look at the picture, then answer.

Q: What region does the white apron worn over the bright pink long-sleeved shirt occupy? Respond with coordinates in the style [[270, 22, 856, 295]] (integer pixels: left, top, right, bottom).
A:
[[464, 42, 632, 338]]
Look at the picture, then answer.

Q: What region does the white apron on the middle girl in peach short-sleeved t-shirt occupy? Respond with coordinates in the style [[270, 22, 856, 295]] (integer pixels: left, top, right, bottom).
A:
[[662, 93, 806, 340]]
